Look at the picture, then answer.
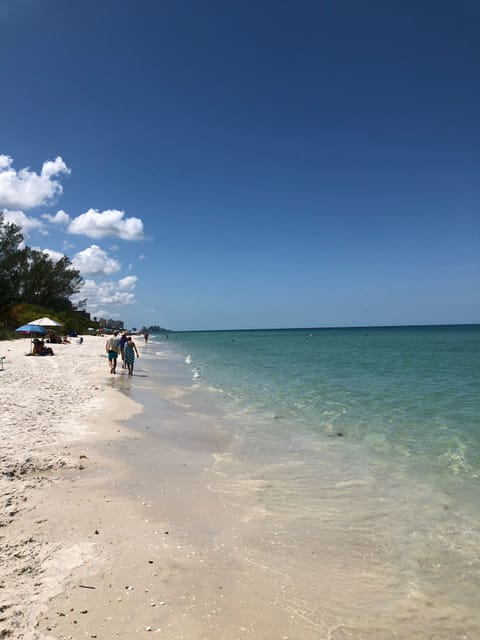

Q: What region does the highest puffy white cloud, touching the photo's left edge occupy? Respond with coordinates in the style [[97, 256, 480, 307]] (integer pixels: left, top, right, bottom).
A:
[[0, 155, 71, 209]]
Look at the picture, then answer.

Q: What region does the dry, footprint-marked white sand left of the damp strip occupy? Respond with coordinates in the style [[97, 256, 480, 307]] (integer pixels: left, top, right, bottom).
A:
[[0, 336, 140, 638]]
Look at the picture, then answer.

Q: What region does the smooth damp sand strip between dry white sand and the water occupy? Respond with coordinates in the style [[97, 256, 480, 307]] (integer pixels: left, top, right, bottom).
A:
[[33, 344, 296, 640]]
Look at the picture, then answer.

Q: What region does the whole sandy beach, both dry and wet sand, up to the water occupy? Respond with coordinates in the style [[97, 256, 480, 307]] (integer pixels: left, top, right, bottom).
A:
[[0, 336, 286, 640]]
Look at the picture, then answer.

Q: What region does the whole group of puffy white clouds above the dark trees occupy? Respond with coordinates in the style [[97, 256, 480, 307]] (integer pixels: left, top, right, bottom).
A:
[[0, 154, 144, 318]]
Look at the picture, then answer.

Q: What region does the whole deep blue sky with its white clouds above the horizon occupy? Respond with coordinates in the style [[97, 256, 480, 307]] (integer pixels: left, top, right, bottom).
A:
[[0, 0, 480, 330]]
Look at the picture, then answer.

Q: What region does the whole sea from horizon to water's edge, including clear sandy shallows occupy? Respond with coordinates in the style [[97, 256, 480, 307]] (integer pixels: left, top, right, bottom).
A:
[[132, 325, 480, 640]]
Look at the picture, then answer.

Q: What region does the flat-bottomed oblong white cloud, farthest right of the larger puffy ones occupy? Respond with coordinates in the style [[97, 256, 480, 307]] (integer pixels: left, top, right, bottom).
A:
[[68, 209, 143, 240]]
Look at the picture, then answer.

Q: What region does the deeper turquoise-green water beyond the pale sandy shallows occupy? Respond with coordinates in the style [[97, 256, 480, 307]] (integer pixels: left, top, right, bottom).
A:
[[164, 326, 480, 482]]
